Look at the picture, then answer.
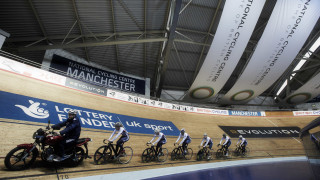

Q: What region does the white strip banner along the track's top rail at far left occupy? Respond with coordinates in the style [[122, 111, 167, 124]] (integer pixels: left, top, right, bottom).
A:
[[0, 56, 66, 86]]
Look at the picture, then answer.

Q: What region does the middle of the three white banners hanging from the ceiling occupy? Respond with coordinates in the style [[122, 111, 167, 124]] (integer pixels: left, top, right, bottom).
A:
[[220, 0, 320, 104]]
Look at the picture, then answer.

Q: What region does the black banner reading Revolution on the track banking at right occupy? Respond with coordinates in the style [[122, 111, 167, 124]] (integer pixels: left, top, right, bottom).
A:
[[219, 126, 300, 138]]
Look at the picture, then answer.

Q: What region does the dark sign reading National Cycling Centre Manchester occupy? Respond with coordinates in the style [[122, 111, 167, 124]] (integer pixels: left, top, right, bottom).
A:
[[50, 54, 145, 95]]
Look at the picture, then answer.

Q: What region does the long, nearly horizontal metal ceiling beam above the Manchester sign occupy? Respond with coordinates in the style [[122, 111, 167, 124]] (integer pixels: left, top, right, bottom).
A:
[[18, 38, 167, 52]]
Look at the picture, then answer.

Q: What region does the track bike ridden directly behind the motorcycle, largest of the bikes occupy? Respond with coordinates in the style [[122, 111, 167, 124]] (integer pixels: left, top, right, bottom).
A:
[[94, 139, 133, 164]]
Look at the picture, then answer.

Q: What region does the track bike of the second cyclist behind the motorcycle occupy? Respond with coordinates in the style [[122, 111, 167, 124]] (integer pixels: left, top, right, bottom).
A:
[[141, 143, 168, 162]]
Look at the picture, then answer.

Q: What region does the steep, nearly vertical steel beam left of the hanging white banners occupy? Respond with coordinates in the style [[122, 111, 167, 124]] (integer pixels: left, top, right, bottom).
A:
[[156, 0, 182, 98]]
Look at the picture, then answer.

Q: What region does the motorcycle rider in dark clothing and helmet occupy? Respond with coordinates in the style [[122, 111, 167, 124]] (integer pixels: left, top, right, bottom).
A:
[[52, 109, 81, 162]]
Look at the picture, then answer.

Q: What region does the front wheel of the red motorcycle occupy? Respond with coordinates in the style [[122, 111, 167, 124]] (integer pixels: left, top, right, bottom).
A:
[[4, 147, 38, 171]]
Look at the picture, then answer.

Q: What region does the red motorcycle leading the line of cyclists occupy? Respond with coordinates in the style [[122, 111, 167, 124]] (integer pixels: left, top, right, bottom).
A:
[[4, 120, 92, 171]]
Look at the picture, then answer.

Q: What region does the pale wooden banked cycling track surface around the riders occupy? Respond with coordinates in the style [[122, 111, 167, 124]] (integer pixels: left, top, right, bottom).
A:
[[0, 70, 320, 179]]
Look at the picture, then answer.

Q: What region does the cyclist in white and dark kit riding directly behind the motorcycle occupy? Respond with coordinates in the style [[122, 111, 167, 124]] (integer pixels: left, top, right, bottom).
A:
[[108, 122, 130, 157]]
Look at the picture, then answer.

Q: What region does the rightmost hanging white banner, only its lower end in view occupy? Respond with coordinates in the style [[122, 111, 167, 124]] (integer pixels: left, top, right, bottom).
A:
[[285, 73, 320, 104]]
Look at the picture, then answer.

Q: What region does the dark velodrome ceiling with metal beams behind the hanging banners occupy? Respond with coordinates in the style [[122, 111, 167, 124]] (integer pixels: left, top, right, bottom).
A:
[[0, 0, 320, 107]]
